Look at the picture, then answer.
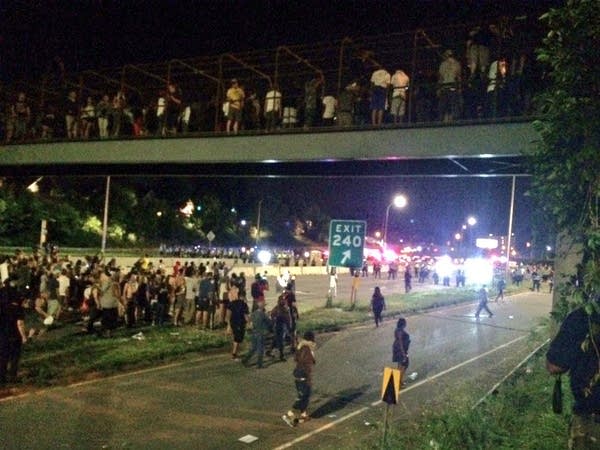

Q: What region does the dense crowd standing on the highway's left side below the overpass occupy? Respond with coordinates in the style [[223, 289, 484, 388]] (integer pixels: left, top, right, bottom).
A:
[[0, 250, 298, 381]]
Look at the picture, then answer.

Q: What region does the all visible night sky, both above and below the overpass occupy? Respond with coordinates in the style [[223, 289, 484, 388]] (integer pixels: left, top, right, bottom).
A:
[[0, 0, 557, 248]]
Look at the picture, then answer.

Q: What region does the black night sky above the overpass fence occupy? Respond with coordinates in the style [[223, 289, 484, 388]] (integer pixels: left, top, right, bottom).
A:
[[0, 0, 557, 79]]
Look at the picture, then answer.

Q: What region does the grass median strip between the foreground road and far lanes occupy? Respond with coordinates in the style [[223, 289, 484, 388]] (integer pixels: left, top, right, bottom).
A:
[[12, 288, 528, 390]]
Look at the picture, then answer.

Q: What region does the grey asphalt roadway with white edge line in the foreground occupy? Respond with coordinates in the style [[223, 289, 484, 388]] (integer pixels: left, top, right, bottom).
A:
[[0, 293, 551, 449]]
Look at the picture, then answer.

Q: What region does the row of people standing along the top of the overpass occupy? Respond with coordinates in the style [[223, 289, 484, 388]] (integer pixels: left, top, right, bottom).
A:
[[0, 17, 541, 143]]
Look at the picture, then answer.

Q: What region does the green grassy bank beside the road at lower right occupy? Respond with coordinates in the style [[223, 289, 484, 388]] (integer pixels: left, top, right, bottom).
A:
[[382, 348, 572, 450]]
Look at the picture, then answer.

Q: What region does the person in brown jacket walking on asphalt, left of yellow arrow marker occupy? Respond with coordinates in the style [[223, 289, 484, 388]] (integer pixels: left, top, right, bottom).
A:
[[282, 331, 316, 427]]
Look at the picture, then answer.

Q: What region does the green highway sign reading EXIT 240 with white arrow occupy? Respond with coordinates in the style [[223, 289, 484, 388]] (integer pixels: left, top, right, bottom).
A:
[[328, 220, 367, 267]]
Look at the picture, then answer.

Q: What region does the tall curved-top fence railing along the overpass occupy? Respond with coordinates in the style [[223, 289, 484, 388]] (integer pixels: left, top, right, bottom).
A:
[[0, 17, 541, 143]]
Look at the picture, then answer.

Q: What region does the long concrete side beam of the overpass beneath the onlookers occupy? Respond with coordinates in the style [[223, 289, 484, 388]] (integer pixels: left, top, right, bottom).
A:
[[0, 119, 538, 177]]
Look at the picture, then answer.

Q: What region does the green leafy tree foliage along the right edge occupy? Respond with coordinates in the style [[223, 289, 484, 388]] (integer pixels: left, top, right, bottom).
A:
[[531, 0, 600, 309]]
